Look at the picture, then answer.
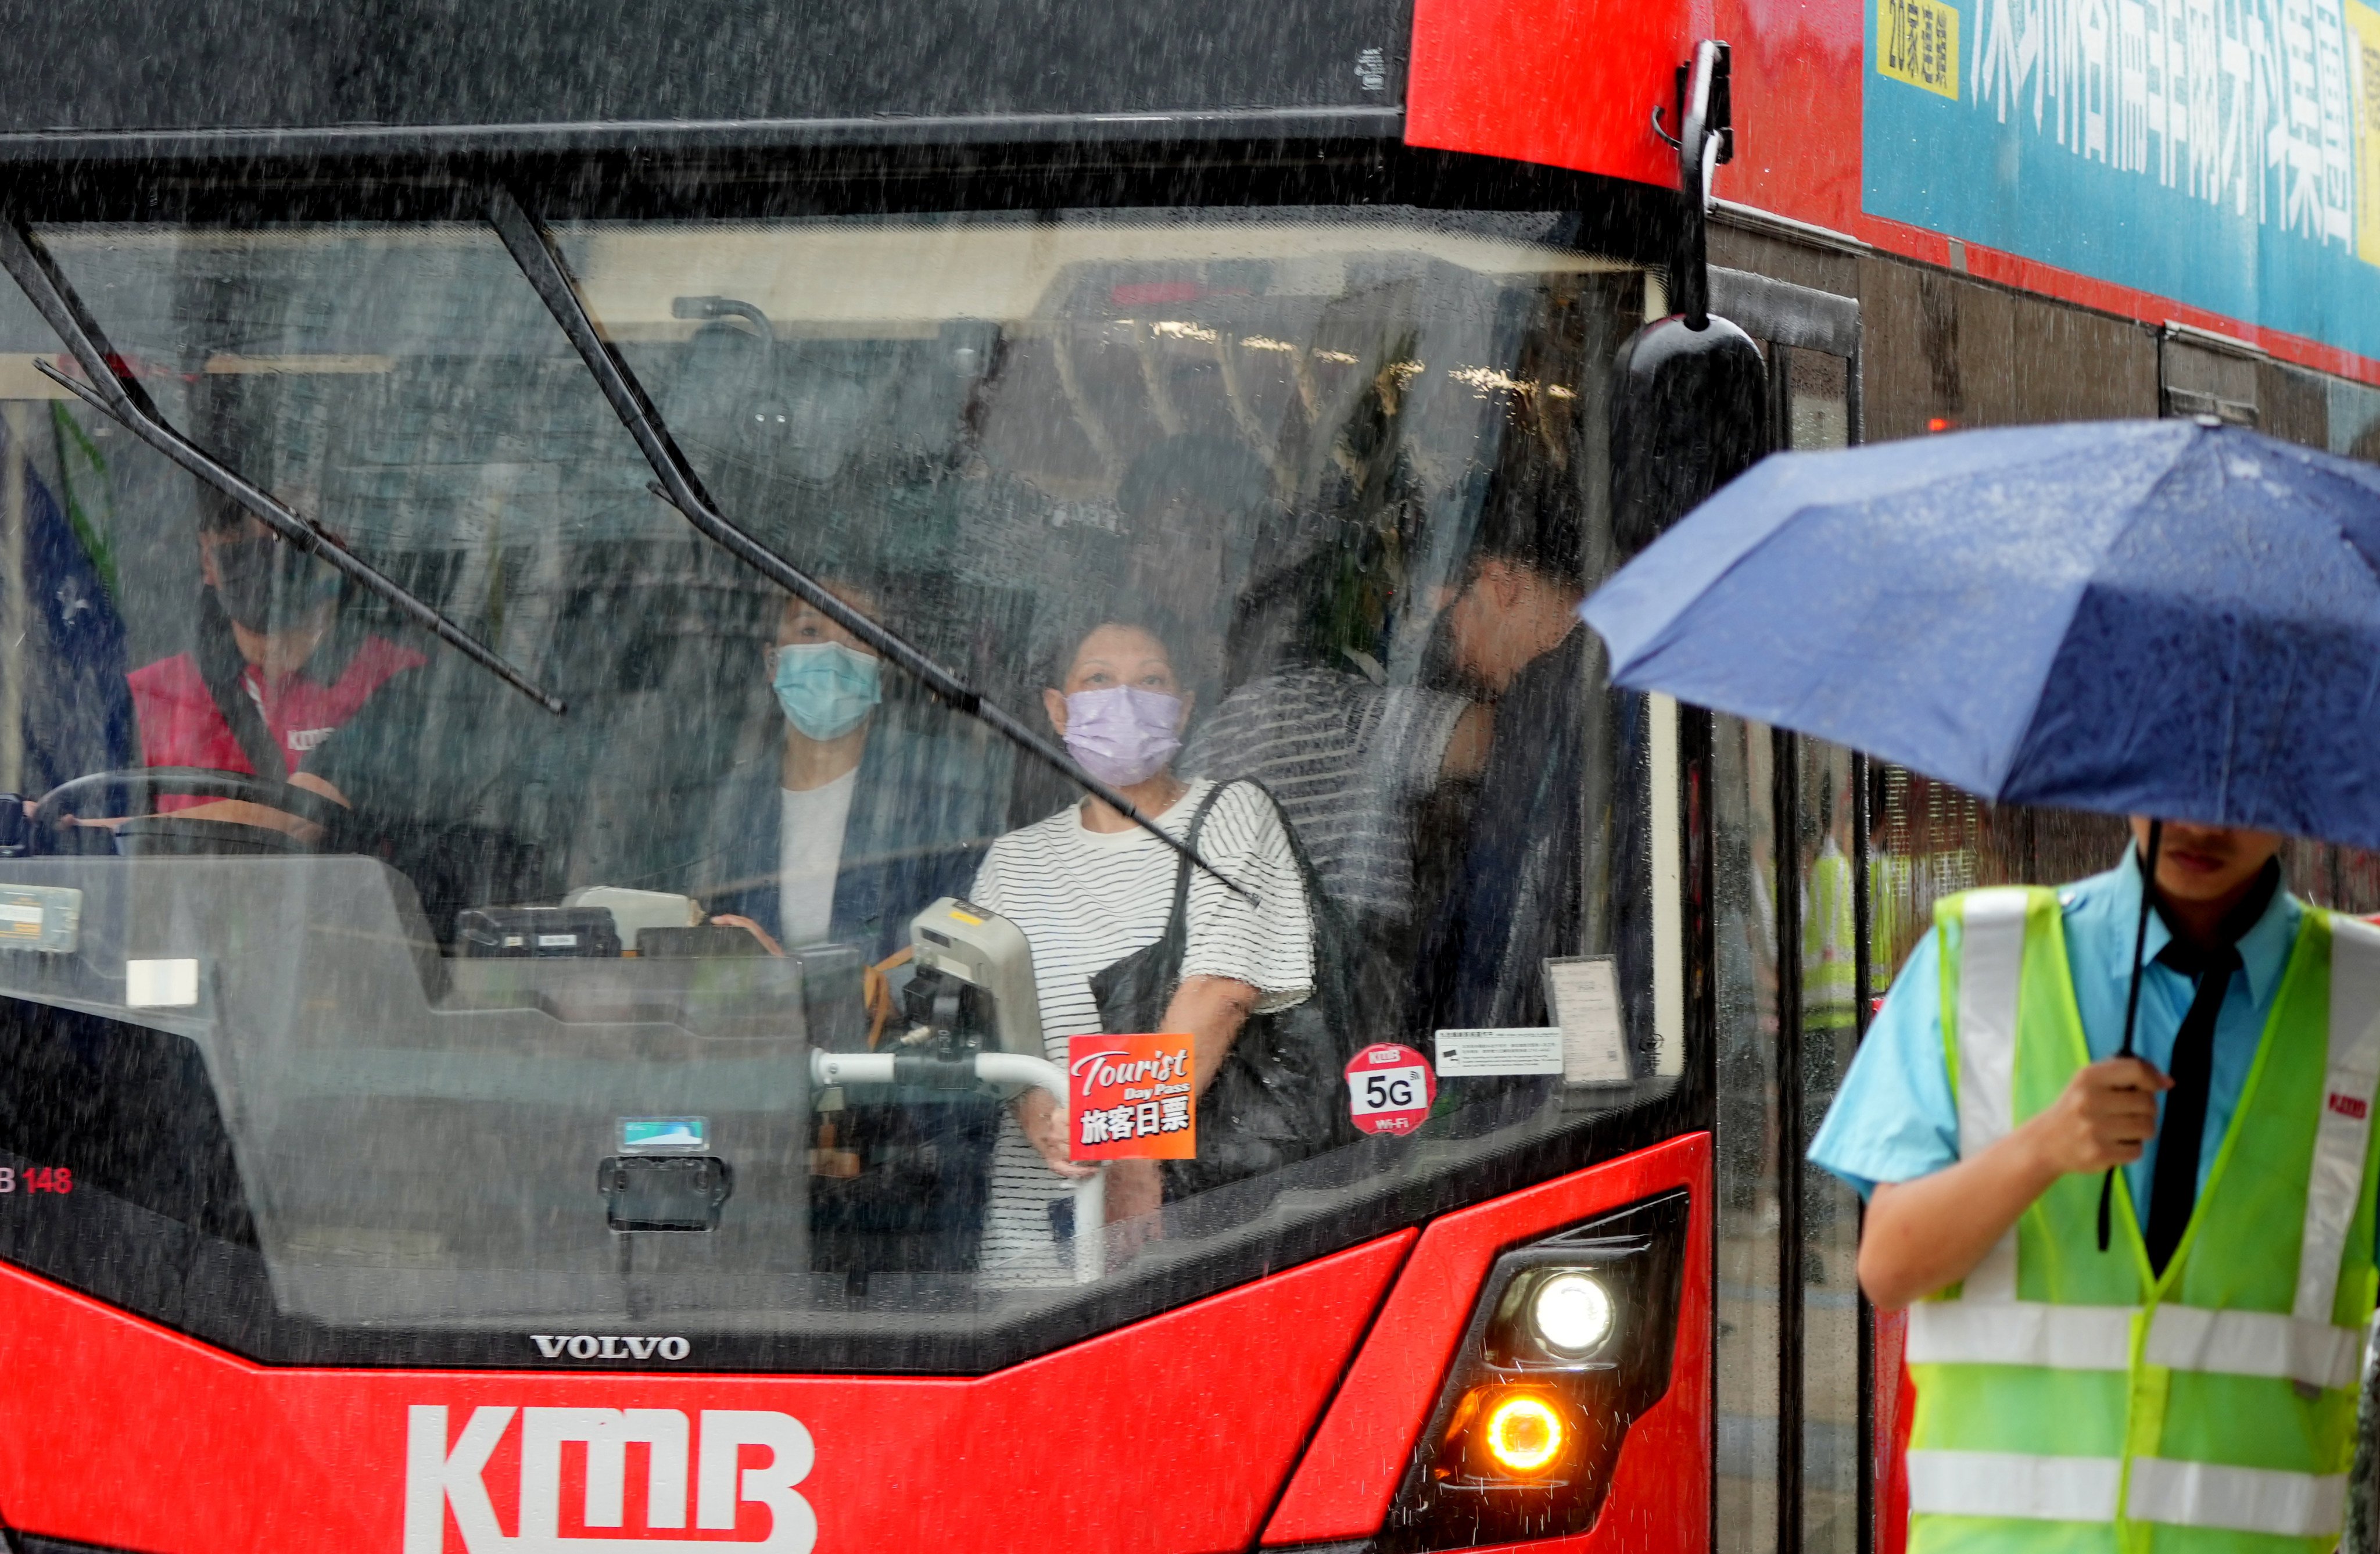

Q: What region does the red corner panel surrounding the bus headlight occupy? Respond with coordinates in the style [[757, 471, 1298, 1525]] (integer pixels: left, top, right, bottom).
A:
[[1264, 1133, 1711, 1549]]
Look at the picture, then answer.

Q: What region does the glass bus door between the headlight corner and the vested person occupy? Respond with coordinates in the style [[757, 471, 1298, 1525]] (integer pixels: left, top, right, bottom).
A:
[[1711, 267, 1897, 1554]]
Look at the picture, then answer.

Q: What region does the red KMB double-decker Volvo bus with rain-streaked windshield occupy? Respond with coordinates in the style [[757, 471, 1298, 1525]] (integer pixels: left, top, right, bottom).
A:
[[0, 0, 2380, 1554]]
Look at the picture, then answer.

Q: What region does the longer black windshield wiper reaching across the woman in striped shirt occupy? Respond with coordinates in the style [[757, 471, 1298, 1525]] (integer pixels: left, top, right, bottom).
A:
[[488, 188, 1257, 902]]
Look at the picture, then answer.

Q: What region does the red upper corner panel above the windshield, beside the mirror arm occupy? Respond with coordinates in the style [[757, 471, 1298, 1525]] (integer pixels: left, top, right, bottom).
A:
[[1404, 0, 1692, 188]]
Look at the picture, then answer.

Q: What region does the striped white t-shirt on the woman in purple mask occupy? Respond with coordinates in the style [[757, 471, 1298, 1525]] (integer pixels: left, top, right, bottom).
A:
[[969, 783, 1314, 1285]]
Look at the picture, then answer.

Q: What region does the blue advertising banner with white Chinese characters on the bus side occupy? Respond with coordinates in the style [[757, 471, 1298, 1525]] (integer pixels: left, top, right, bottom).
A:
[[1861, 0, 2380, 357]]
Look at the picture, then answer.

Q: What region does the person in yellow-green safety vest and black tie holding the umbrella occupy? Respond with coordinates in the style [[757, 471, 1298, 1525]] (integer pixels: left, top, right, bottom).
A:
[[1809, 819, 2380, 1554]]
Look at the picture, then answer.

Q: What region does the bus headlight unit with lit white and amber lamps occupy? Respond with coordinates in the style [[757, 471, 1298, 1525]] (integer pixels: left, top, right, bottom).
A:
[[1378, 1193, 1687, 1554]]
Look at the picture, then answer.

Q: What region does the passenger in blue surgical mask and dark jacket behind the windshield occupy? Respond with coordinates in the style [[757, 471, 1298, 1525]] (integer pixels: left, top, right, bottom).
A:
[[697, 581, 1007, 961]]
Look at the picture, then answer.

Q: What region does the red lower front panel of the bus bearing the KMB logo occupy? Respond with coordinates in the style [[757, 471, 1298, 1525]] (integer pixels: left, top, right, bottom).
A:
[[0, 1230, 1416, 1554]]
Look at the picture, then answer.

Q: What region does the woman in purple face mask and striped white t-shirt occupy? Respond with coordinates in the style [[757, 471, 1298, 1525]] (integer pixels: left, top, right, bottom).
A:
[[969, 621, 1314, 1283]]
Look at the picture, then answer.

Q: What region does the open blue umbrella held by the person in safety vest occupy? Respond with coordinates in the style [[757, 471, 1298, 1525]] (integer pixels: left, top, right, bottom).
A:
[[1580, 421, 2380, 847]]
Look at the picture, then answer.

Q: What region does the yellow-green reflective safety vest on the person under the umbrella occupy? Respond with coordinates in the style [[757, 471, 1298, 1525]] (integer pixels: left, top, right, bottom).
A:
[[1909, 887, 2380, 1554]]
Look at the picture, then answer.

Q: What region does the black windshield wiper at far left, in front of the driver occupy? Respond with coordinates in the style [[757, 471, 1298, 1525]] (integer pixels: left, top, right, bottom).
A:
[[0, 212, 567, 711]]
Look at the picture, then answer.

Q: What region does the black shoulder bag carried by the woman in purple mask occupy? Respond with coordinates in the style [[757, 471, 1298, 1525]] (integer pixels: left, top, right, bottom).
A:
[[1090, 778, 1397, 1199]]
